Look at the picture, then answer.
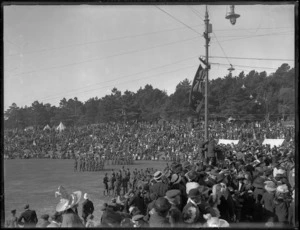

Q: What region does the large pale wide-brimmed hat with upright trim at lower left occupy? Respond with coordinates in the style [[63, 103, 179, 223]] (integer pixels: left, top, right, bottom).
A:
[[55, 186, 82, 212]]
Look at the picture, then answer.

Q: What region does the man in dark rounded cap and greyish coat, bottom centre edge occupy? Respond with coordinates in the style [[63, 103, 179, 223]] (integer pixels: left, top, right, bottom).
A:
[[149, 197, 171, 228]]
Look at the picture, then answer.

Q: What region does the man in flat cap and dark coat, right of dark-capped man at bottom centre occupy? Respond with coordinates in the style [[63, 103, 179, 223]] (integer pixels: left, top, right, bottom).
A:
[[165, 189, 183, 227]]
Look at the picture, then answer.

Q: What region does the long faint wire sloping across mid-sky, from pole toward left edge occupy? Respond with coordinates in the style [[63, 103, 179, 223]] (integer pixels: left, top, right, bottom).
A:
[[10, 37, 198, 79]]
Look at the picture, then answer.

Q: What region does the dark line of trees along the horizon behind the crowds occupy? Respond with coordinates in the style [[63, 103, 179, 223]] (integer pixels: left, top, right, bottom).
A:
[[4, 63, 296, 128]]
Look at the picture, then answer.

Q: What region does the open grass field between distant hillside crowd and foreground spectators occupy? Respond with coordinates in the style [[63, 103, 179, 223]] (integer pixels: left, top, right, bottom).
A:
[[4, 159, 166, 225]]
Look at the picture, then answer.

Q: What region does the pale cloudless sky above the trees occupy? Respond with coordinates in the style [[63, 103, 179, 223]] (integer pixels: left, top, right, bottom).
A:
[[3, 2, 295, 111]]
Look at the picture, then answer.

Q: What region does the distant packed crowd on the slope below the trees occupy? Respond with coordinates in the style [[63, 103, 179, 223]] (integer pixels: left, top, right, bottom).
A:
[[4, 121, 295, 164]]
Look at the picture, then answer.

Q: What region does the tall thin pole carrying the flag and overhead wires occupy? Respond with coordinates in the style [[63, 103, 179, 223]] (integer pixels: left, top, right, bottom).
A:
[[204, 5, 210, 140]]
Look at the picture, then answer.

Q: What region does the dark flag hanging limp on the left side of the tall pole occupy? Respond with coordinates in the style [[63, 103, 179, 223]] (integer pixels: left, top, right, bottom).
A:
[[189, 64, 206, 113]]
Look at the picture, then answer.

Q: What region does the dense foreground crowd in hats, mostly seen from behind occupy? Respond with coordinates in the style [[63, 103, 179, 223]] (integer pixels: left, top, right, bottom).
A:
[[7, 140, 297, 228]]
